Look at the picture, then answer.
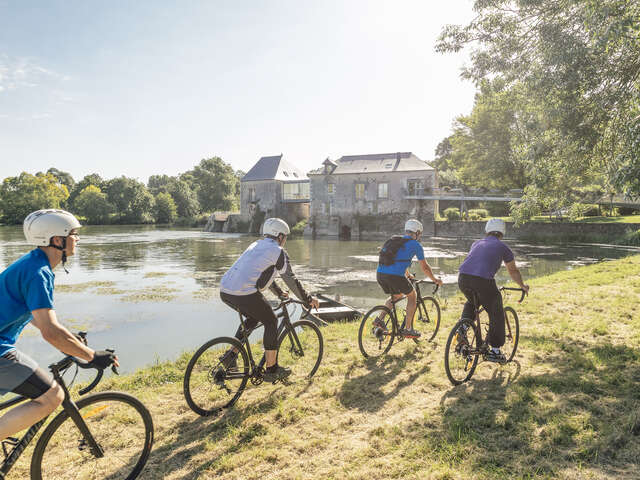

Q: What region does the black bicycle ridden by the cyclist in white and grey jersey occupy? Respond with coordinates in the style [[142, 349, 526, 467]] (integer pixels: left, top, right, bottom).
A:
[[183, 298, 324, 417]]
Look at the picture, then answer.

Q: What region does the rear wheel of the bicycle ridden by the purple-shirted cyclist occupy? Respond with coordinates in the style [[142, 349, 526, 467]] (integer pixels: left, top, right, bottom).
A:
[[444, 318, 478, 385]]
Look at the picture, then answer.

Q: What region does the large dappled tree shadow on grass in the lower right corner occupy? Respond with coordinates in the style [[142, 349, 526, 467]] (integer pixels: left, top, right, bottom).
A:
[[428, 337, 640, 478]]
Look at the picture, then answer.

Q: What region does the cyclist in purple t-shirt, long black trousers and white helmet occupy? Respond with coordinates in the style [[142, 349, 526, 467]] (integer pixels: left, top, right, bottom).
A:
[[458, 218, 529, 363]]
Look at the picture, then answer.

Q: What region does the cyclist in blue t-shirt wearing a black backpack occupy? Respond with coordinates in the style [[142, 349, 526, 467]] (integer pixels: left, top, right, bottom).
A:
[[373, 219, 442, 338]]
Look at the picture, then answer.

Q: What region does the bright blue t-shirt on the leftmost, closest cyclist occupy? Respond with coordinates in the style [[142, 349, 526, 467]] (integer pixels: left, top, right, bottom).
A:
[[0, 248, 55, 356]]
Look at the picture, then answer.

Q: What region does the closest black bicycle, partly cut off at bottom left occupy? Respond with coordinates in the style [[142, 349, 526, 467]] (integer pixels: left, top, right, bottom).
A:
[[0, 332, 153, 480]]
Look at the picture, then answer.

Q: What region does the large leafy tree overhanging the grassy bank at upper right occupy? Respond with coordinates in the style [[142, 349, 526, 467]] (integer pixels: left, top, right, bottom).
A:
[[436, 0, 640, 216]]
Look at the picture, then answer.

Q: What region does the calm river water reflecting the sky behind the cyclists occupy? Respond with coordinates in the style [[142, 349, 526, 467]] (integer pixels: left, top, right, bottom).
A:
[[0, 226, 640, 371]]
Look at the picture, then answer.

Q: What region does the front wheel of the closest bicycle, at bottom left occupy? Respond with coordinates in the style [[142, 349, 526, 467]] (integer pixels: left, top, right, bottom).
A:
[[31, 392, 153, 480]]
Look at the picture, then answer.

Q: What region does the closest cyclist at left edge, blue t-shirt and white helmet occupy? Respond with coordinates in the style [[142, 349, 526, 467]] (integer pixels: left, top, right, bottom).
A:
[[0, 209, 118, 440]]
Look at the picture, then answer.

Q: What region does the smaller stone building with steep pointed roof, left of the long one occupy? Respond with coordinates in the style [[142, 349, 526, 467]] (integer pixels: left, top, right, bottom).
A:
[[240, 154, 310, 232]]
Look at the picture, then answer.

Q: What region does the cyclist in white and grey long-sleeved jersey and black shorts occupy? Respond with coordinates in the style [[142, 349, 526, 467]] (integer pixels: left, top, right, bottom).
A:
[[220, 218, 319, 382]]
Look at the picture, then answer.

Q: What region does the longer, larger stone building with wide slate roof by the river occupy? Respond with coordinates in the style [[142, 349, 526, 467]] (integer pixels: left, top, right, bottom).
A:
[[305, 152, 438, 239]]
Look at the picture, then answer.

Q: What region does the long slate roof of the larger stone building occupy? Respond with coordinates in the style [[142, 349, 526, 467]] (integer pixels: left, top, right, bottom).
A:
[[308, 152, 433, 175]]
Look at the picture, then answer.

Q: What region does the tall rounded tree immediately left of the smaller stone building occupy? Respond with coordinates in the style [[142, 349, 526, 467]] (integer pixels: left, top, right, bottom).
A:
[[188, 157, 239, 211]]
